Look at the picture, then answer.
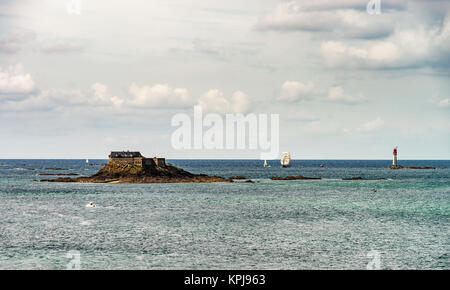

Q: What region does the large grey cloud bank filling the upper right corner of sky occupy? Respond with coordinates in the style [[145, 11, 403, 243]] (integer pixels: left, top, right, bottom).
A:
[[256, 0, 450, 69]]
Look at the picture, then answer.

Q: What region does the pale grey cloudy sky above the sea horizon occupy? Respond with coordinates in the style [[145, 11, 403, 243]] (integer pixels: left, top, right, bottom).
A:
[[0, 0, 450, 160]]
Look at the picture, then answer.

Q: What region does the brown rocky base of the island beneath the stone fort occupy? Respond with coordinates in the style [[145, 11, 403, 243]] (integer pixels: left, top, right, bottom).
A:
[[41, 162, 232, 183]]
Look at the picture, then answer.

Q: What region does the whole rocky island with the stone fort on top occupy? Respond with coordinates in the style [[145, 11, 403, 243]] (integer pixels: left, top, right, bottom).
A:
[[41, 151, 232, 183]]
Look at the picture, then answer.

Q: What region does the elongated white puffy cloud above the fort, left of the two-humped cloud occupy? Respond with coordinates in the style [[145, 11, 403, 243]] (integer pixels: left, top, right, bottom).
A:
[[127, 83, 193, 107]]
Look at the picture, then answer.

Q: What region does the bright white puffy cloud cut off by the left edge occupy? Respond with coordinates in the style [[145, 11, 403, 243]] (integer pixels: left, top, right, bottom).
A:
[[0, 63, 35, 97]]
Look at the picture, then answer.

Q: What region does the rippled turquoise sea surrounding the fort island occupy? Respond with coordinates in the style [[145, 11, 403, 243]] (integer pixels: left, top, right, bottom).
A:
[[0, 160, 450, 269]]
